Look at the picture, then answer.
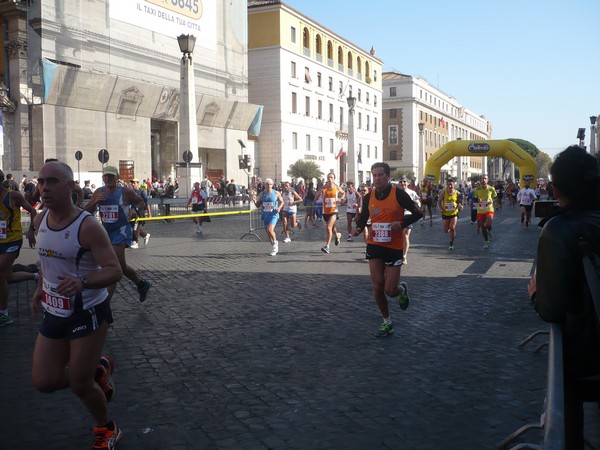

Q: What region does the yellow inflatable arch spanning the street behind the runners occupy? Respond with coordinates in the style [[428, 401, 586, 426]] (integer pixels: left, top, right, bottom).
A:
[[425, 139, 537, 186]]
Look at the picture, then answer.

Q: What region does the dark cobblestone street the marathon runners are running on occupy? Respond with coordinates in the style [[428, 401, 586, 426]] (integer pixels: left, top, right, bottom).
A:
[[0, 206, 596, 450]]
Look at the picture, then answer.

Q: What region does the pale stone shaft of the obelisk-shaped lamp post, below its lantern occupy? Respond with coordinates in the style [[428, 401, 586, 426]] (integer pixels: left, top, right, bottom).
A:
[[177, 50, 197, 197]]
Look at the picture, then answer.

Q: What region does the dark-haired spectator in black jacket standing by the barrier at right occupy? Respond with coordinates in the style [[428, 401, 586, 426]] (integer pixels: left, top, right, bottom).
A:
[[528, 146, 600, 450]]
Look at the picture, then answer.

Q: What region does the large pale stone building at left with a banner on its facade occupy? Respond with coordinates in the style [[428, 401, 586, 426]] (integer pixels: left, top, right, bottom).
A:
[[0, 0, 258, 190]]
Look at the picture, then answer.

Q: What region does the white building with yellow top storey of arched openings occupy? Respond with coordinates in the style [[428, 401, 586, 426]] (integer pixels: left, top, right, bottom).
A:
[[248, 0, 382, 182]]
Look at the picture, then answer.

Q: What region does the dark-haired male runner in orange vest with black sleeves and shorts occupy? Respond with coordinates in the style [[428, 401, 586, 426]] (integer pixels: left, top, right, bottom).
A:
[[354, 162, 423, 337]]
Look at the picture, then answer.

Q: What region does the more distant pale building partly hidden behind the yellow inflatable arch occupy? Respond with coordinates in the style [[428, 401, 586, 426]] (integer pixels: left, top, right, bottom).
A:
[[383, 72, 492, 183]]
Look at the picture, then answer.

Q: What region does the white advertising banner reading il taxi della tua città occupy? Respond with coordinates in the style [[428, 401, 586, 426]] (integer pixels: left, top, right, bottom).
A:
[[110, 0, 217, 50]]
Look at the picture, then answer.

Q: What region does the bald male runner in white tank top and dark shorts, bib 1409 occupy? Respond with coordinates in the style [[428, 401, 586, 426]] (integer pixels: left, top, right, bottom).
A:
[[31, 161, 122, 448]]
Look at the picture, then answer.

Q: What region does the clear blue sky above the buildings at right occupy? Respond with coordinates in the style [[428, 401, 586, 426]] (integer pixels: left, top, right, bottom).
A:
[[283, 0, 600, 157]]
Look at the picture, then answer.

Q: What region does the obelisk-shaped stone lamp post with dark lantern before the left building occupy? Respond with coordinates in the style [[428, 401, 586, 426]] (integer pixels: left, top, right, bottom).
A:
[[177, 34, 202, 201]]
